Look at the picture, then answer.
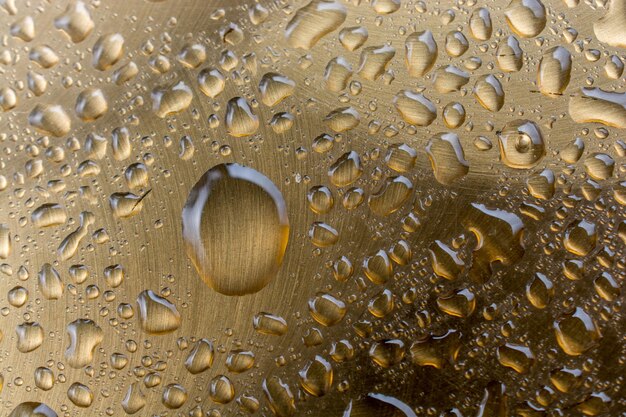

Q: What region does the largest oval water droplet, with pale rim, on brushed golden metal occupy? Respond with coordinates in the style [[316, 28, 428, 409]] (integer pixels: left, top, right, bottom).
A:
[[182, 164, 289, 295]]
